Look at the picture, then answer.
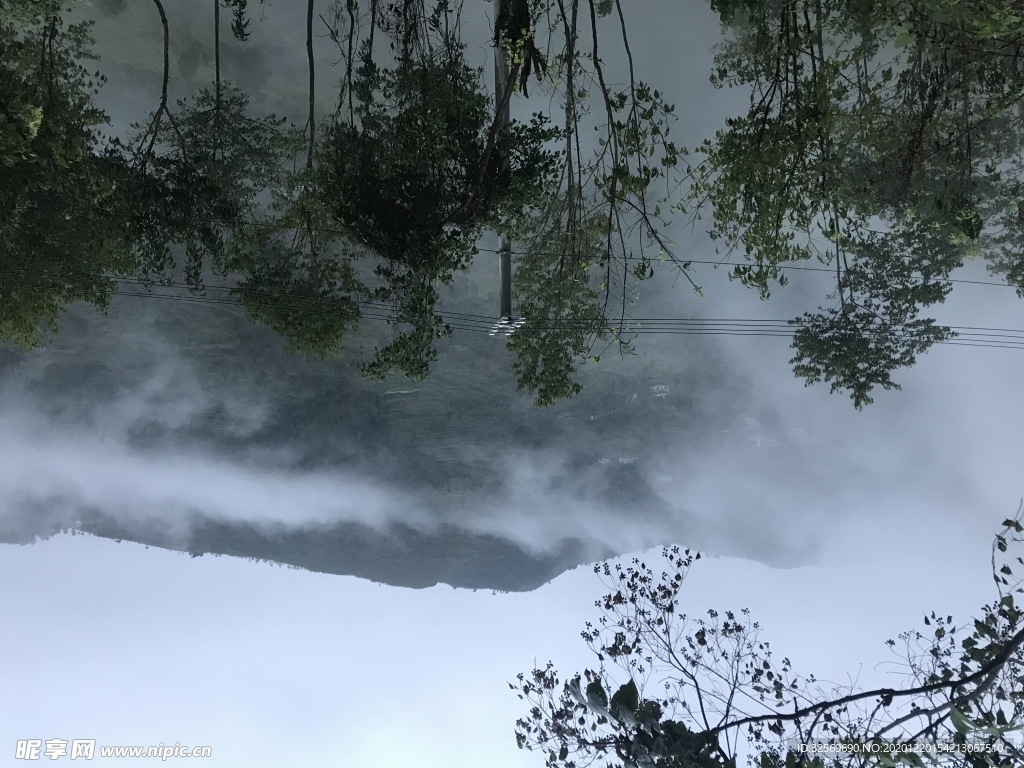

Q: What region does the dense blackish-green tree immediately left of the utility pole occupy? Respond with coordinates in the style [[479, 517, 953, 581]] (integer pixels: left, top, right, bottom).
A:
[[224, 3, 565, 379]]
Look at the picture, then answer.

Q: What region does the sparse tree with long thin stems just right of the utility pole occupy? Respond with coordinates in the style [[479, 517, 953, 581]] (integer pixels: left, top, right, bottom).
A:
[[496, 0, 699, 406]]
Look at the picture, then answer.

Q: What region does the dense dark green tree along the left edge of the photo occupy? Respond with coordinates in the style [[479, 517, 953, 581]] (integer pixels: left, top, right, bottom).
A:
[[0, 0, 133, 348]]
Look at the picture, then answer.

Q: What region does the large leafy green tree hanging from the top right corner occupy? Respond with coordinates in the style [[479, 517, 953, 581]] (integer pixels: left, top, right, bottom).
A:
[[680, 0, 1024, 408]]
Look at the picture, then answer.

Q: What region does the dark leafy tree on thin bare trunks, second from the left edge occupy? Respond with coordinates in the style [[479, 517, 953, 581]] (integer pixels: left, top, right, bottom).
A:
[[117, 0, 300, 291]]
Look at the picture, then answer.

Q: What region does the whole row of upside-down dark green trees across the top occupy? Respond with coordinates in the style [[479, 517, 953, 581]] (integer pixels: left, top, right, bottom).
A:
[[6, 0, 1024, 408]]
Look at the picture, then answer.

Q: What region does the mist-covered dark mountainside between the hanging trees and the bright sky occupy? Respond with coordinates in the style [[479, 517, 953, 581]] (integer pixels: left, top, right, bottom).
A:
[[0, 256, 1024, 591]]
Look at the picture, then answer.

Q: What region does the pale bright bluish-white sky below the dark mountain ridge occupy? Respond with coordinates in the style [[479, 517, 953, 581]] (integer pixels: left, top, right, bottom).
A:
[[0, 535, 1003, 768]]
